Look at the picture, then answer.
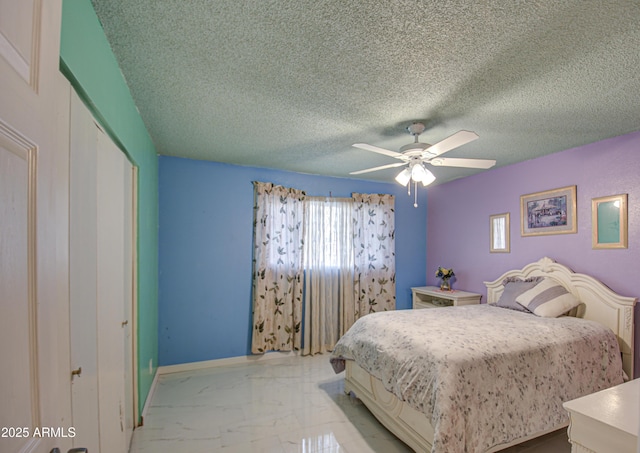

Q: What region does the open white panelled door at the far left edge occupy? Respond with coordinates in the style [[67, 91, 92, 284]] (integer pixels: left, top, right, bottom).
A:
[[0, 0, 74, 453]]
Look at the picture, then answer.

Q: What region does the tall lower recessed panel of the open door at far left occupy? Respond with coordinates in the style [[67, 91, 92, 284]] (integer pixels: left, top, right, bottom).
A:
[[0, 124, 40, 452]]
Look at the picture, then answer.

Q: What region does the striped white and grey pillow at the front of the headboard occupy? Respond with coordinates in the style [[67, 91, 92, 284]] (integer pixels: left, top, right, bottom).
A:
[[516, 278, 580, 318]]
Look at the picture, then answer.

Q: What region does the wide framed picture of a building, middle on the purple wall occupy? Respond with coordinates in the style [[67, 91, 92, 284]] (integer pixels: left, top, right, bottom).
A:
[[520, 186, 578, 236]]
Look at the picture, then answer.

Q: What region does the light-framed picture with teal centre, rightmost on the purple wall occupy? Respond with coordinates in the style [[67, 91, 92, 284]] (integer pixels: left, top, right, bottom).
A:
[[591, 193, 628, 249]]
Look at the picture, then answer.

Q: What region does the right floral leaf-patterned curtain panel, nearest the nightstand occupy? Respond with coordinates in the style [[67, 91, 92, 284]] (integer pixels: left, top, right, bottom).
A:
[[352, 193, 396, 319]]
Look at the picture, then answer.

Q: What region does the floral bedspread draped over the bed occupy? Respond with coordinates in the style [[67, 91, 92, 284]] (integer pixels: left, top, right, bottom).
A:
[[330, 305, 623, 453]]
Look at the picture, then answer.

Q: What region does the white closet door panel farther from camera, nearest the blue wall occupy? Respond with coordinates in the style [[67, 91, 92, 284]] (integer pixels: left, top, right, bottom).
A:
[[96, 125, 131, 452]]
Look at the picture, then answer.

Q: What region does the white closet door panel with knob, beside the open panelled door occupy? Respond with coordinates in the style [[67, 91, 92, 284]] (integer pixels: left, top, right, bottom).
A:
[[69, 92, 100, 453]]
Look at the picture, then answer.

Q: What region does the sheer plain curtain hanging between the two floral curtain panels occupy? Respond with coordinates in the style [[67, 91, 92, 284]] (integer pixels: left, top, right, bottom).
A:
[[303, 197, 355, 355]]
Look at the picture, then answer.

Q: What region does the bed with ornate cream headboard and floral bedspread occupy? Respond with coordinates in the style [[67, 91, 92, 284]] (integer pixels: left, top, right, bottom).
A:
[[330, 258, 637, 453]]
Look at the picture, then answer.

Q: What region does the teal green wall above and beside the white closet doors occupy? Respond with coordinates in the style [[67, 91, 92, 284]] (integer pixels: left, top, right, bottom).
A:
[[60, 0, 158, 418]]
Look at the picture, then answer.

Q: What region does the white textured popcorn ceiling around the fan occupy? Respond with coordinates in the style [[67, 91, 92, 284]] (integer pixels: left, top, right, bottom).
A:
[[92, 0, 640, 183]]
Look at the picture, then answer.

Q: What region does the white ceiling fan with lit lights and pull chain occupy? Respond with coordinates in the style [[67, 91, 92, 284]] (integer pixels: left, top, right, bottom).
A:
[[350, 122, 496, 191]]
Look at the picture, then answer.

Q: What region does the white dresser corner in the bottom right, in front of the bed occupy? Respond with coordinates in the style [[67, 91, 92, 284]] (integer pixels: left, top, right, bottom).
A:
[[564, 379, 640, 453]]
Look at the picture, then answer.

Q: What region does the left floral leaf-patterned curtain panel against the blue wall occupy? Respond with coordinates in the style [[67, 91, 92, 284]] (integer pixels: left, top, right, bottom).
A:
[[251, 182, 305, 354]]
